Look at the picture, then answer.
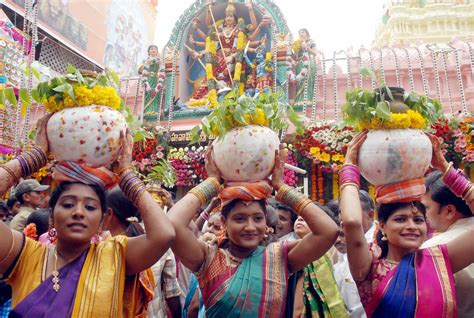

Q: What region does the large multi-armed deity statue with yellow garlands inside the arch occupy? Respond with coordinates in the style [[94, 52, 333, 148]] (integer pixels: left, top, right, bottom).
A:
[[186, 2, 270, 107]]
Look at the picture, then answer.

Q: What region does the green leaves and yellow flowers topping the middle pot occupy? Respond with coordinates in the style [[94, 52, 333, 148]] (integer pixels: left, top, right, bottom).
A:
[[191, 90, 304, 144]]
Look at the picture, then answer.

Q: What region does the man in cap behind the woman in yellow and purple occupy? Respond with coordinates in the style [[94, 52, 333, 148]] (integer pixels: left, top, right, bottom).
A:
[[10, 179, 49, 232]]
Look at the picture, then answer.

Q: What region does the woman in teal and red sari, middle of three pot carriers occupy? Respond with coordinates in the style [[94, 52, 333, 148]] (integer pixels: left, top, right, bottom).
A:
[[168, 148, 338, 317]]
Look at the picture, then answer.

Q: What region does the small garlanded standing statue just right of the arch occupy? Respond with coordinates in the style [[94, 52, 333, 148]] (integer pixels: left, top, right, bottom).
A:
[[287, 29, 318, 105]]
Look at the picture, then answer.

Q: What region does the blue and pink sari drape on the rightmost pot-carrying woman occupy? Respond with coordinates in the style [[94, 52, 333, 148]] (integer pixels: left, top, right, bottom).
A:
[[365, 245, 457, 318]]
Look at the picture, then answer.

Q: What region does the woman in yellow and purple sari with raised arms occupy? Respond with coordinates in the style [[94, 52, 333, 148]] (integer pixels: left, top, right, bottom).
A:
[[0, 117, 175, 317]]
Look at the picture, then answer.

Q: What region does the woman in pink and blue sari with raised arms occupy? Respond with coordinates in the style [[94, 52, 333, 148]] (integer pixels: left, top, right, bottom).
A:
[[339, 132, 474, 317]]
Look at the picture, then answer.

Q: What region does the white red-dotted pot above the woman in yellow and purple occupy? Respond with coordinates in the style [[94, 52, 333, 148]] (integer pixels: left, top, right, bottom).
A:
[[47, 105, 127, 167]]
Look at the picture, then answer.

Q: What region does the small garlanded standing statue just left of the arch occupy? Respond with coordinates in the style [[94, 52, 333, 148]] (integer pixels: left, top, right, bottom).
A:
[[138, 45, 165, 121]]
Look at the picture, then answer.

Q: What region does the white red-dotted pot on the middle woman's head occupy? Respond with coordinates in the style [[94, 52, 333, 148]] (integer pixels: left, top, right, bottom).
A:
[[213, 125, 280, 181]]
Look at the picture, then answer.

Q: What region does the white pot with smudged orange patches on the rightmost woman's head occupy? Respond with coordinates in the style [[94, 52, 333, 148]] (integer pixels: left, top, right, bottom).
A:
[[359, 129, 432, 185]]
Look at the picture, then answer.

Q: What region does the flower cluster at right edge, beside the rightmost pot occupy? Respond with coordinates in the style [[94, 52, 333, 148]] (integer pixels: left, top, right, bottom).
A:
[[431, 115, 474, 168]]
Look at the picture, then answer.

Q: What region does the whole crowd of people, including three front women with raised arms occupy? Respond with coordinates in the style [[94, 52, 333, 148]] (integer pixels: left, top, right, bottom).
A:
[[0, 118, 474, 317]]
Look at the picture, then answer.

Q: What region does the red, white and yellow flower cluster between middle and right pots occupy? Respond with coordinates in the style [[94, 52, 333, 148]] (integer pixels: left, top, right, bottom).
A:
[[293, 125, 354, 172]]
